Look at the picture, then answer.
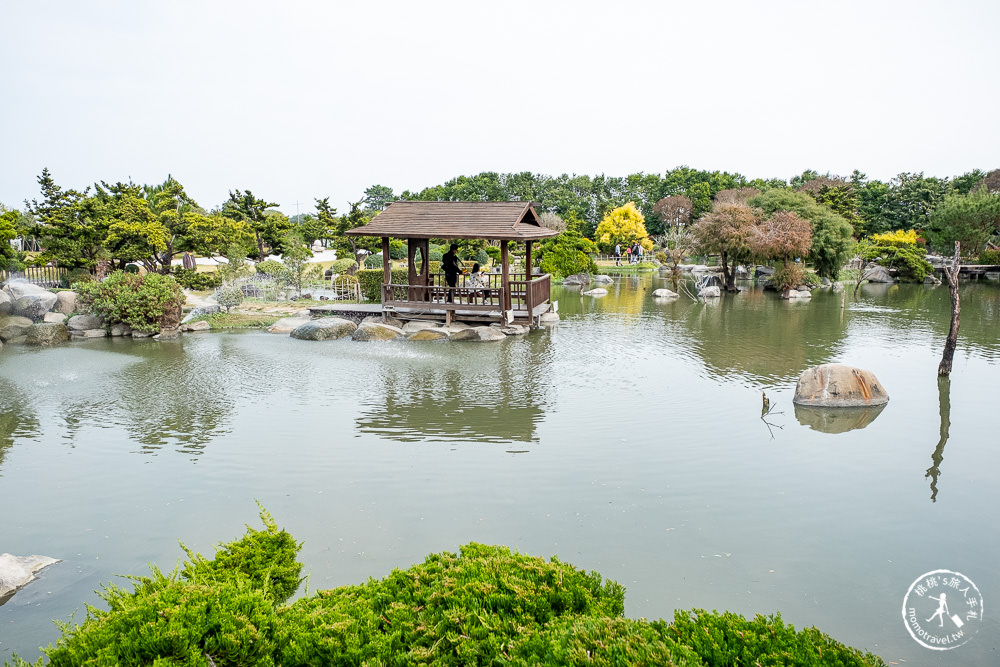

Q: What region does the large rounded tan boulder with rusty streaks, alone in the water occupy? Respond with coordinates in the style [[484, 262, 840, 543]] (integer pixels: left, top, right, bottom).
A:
[[792, 364, 889, 408]]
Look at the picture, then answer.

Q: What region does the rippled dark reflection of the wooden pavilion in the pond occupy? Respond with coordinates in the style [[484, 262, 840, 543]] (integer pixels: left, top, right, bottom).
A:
[[358, 340, 547, 443]]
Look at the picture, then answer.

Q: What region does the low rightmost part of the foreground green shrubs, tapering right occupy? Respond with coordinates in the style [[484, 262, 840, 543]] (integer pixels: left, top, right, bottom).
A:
[[668, 609, 885, 667]]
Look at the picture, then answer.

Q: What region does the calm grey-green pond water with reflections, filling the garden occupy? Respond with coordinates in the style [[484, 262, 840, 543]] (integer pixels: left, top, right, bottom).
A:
[[0, 276, 1000, 665]]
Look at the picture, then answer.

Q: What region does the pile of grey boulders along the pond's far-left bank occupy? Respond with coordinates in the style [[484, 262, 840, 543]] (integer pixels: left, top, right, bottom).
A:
[[0, 280, 210, 347]]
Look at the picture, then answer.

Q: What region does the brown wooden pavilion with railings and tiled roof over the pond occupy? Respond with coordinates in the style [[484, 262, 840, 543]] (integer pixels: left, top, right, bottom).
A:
[[347, 201, 558, 323]]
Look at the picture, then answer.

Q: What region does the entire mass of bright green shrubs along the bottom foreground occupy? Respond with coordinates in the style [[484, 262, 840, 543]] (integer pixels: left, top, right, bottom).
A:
[[14, 508, 885, 667]]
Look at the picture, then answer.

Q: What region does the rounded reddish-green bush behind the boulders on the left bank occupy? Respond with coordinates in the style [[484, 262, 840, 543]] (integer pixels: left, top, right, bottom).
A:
[[73, 271, 184, 333]]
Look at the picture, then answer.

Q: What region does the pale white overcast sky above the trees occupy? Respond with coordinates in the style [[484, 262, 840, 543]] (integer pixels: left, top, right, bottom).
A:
[[0, 0, 1000, 215]]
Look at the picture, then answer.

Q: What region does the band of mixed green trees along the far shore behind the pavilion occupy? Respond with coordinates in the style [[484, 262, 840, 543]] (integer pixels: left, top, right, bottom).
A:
[[0, 166, 1000, 280]]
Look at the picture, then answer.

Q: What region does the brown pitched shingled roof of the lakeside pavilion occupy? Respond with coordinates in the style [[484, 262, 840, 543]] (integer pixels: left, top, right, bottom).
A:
[[347, 201, 559, 241]]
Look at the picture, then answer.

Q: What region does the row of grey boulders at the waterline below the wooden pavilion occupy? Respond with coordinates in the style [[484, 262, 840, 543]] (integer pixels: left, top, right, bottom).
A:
[[268, 313, 558, 342]]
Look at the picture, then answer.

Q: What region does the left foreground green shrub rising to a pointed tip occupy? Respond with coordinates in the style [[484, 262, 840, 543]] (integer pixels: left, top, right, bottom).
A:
[[35, 509, 301, 667]]
